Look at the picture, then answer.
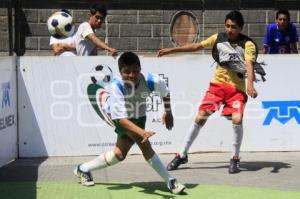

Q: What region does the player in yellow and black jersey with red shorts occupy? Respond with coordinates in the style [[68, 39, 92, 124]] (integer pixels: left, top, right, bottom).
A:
[[158, 11, 257, 173]]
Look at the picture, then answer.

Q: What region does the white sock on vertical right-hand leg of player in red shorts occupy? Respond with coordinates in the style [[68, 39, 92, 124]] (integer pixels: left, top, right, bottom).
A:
[[232, 124, 243, 157]]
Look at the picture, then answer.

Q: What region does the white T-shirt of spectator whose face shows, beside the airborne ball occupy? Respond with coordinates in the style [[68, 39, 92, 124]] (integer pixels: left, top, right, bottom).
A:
[[75, 22, 97, 56]]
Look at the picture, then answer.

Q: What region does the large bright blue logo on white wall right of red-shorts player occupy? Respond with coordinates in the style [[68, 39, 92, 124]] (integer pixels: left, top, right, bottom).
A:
[[262, 101, 300, 125]]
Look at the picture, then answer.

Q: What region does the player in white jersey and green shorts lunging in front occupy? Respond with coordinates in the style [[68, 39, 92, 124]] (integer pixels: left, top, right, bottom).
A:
[[74, 52, 185, 194]]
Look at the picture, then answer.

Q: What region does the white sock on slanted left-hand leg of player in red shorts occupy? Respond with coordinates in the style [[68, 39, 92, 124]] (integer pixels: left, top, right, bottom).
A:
[[179, 123, 201, 157]]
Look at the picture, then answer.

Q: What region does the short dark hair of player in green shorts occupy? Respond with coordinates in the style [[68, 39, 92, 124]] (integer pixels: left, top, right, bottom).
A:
[[118, 52, 141, 71]]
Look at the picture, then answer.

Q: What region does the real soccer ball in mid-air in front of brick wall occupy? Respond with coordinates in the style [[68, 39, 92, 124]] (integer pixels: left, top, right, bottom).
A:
[[47, 11, 74, 39]]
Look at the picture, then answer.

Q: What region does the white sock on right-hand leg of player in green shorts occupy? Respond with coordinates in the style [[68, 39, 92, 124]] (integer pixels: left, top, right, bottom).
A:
[[147, 153, 174, 182]]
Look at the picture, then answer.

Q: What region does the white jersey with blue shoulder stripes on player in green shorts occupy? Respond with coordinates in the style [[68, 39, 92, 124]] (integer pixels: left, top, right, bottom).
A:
[[106, 73, 169, 120]]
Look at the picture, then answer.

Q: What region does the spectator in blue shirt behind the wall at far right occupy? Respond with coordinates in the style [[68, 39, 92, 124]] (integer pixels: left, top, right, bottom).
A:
[[264, 9, 298, 54]]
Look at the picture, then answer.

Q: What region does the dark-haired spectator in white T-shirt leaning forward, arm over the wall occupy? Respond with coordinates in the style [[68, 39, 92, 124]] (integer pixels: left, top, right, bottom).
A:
[[75, 4, 118, 56]]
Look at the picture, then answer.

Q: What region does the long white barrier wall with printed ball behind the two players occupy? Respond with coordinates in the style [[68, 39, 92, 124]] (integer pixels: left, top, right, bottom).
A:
[[19, 55, 300, 157]]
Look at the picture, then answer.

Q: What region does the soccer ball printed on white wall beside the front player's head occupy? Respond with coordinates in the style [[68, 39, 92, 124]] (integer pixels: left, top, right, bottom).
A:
[[91, 64, 113, 87]]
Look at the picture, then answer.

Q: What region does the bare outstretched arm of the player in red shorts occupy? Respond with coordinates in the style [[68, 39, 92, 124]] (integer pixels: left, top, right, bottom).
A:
[[157, 43, 203, 57]]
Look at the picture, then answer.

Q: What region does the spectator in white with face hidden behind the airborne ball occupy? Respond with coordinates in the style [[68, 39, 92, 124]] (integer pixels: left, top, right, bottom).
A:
[[49, 9, 76, 56]]
